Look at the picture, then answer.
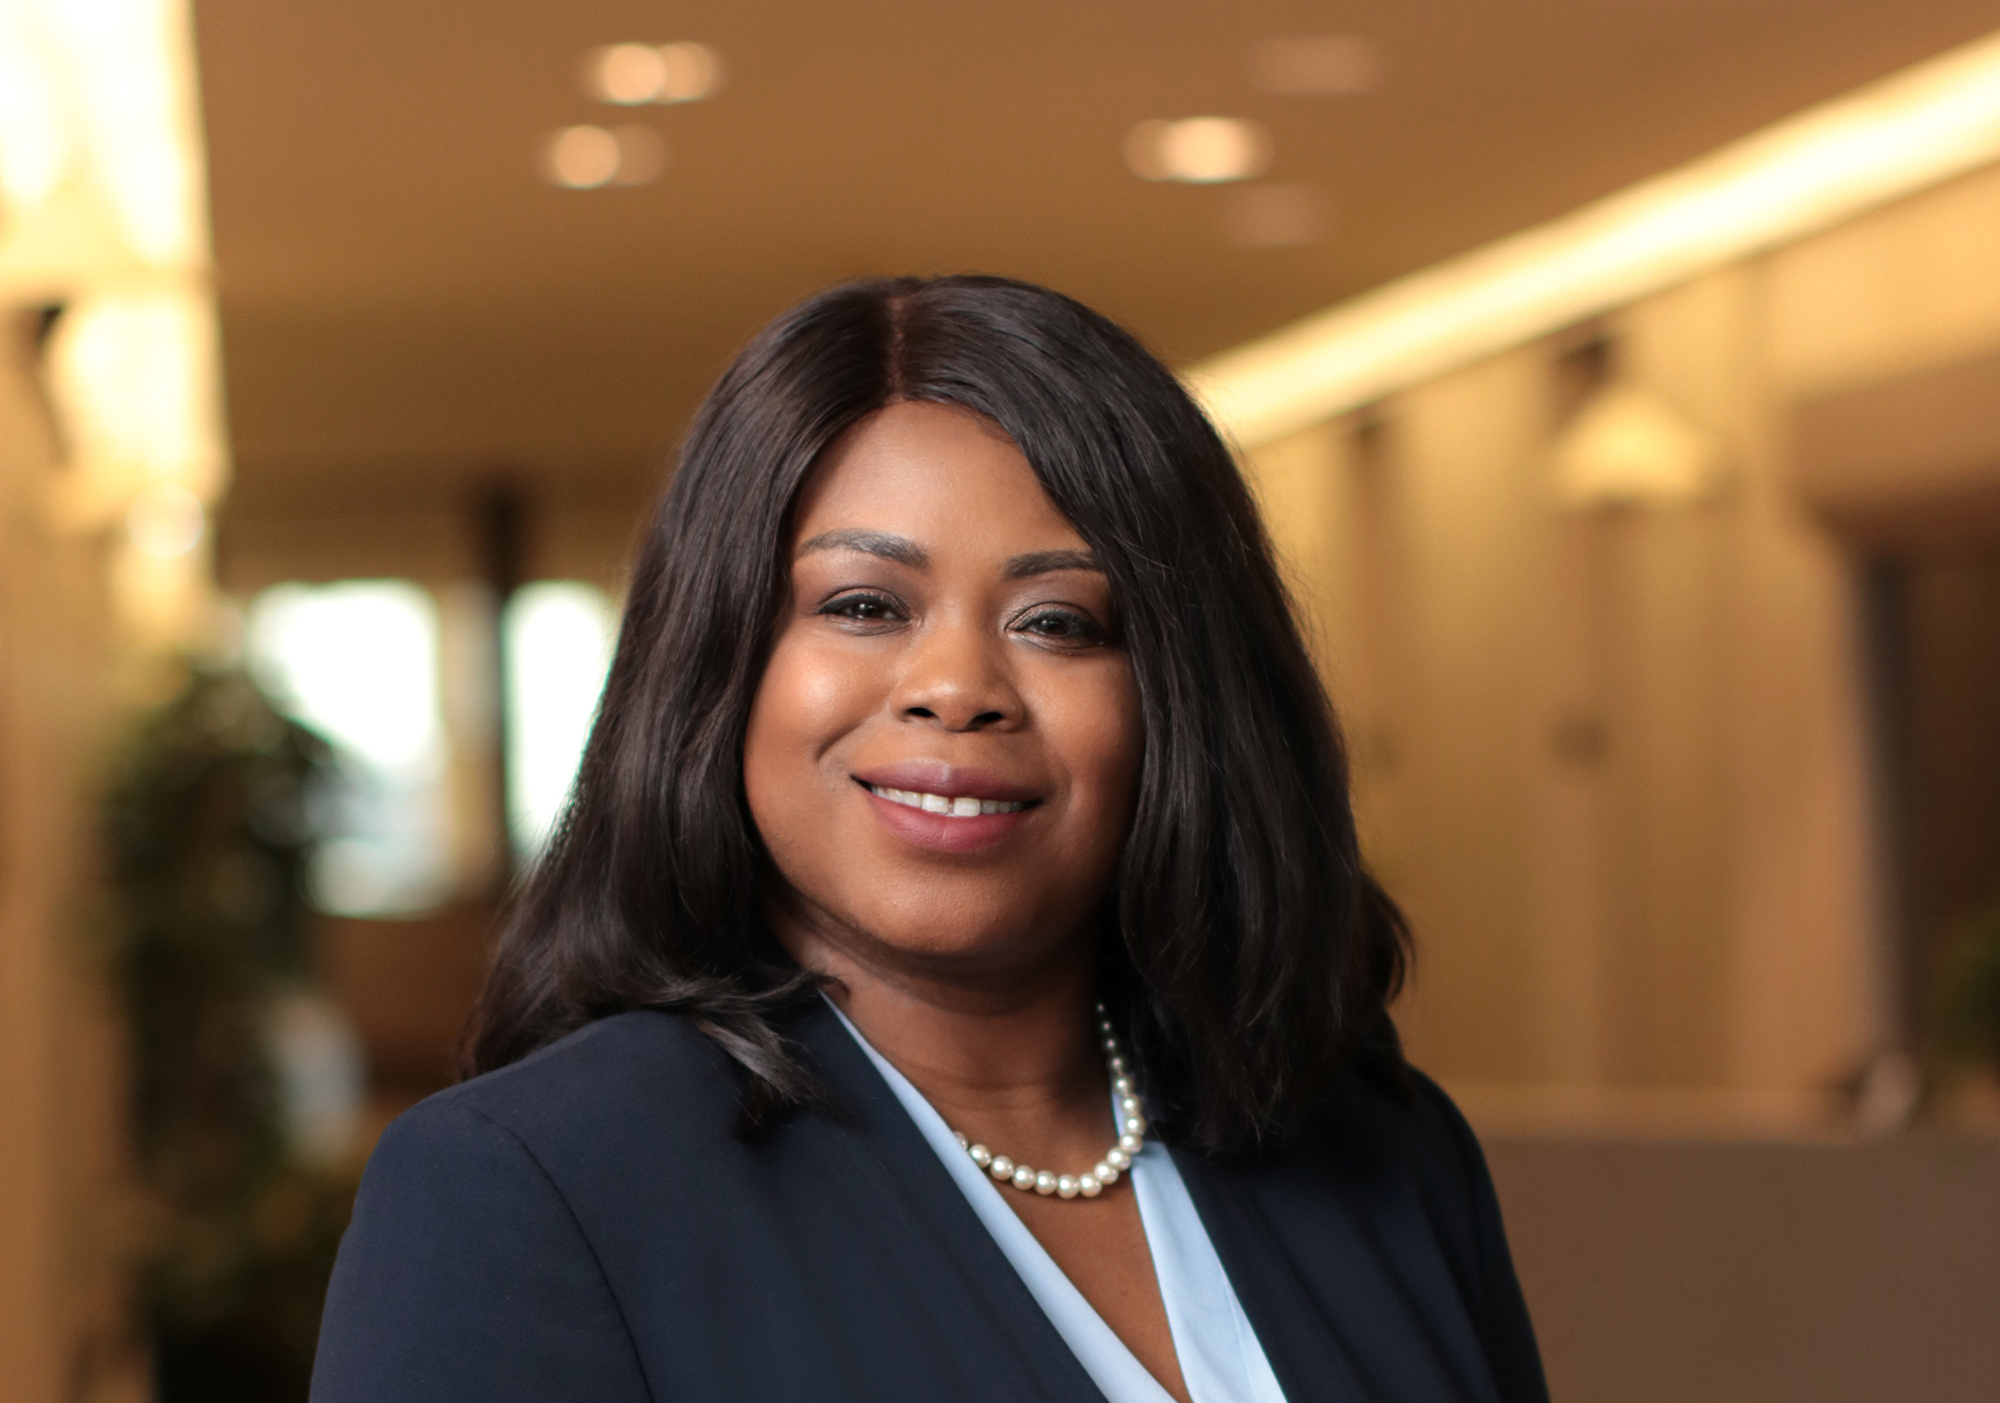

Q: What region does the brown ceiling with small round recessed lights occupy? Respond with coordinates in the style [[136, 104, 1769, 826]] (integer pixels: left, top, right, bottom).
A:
[[196, 0, 2000, 512]]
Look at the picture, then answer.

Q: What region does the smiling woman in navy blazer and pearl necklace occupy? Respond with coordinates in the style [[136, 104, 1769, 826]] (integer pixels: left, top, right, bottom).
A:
[[314, 278, 1544, 1403]]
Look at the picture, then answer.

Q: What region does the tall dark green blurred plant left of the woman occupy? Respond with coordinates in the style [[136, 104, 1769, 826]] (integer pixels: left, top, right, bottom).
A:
[[102, 664, 354, 1403]]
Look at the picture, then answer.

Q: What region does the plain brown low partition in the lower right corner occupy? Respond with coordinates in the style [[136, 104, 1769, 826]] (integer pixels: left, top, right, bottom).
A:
[[1486, 1135, 2000, 1403]]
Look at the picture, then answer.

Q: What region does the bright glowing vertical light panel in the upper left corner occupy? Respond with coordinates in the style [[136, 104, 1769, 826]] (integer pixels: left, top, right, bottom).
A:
[[0, 0, 228, 652]]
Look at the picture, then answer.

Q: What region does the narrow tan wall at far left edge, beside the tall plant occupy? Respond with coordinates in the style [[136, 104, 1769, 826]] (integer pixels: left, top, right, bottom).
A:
[[0, 318, 142, 1403]]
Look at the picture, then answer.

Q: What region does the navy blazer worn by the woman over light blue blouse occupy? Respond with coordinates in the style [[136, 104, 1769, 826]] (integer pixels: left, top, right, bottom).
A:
[[312, 1001, 1548, 1403]]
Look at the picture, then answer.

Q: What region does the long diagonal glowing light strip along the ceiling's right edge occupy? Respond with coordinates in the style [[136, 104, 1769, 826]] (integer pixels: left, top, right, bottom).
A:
[[1186, 34, 2000, 448]]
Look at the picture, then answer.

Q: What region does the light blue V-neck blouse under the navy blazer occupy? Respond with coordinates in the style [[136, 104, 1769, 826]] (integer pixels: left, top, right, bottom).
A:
[[828, 999, 1284, 1403]]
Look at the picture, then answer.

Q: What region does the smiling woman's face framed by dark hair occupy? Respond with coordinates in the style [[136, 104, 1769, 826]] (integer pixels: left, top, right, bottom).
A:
[[744, 404, 1140, 973]]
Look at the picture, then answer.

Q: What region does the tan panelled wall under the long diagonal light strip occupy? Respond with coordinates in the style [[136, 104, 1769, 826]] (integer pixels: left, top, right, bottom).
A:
[[1248, 159, 2000, 1123]]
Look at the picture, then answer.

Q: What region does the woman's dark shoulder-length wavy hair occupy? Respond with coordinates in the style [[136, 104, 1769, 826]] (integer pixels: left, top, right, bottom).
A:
[[460, 276, 1408, 1151]]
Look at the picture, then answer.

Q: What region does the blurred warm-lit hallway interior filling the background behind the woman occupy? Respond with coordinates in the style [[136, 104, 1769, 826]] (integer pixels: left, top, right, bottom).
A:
[[0, 0, 2000, 1403]]
